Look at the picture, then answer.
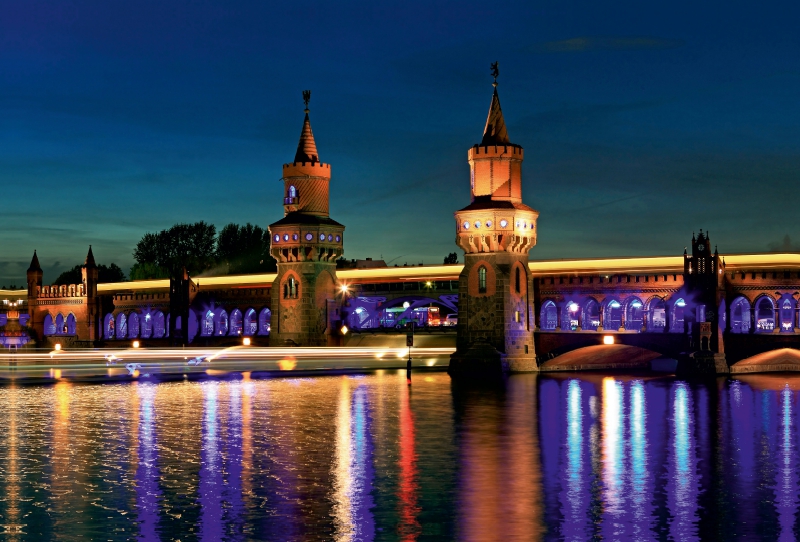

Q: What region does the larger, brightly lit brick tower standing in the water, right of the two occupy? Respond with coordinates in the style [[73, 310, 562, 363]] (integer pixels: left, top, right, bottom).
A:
[[449, 64, 539, 376]]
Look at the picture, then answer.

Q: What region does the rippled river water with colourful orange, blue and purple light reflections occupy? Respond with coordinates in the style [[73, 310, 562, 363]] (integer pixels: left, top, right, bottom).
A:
[[0, 372, 800, 541]]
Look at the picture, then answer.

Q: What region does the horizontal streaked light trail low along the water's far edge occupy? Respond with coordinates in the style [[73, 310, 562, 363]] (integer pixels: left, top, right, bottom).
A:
[[0, 346, 454, 380]]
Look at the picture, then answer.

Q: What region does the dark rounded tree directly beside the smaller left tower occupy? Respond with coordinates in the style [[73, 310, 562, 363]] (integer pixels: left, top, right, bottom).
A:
[[216, 222, 277, 274]]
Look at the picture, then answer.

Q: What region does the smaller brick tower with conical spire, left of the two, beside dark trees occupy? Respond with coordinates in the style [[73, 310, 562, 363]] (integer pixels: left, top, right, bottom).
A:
[[269, 91, 344, 346]]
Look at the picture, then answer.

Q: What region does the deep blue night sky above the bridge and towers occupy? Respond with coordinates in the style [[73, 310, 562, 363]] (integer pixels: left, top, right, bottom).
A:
[[0, 0, 800, 285]]
